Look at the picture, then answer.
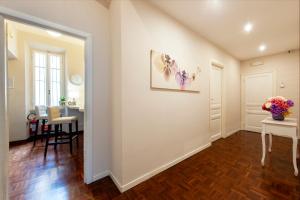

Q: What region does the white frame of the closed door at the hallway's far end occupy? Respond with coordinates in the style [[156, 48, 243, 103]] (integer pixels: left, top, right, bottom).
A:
[[241, 70, 277, 130]]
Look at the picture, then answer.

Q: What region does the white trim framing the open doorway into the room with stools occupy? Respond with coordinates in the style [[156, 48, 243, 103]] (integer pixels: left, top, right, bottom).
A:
[[0, 13, 93, 199]]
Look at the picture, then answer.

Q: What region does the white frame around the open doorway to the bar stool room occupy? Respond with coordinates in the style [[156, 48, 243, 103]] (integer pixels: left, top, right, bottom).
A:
[[0, 6, 93, 199]]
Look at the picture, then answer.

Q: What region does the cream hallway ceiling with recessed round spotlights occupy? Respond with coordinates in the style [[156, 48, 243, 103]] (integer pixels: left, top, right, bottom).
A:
[[149, 0, 300, 60]]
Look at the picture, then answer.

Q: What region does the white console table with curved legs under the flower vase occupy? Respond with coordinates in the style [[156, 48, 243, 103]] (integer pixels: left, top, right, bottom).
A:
[[261, 117, 298, 176]]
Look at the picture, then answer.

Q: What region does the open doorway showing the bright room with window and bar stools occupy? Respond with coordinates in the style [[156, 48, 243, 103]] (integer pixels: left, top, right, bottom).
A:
[[5, 20, 85, 199]]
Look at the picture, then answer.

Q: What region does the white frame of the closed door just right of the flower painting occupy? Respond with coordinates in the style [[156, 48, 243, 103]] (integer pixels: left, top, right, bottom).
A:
[[209, 60, 226, 142]]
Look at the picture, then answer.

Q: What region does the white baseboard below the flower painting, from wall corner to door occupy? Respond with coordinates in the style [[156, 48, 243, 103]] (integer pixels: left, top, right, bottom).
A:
[[119, 142, 211, 192]]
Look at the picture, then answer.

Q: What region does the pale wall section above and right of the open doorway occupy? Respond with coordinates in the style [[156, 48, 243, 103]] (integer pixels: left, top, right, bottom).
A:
[[0, 0, 111, 188]]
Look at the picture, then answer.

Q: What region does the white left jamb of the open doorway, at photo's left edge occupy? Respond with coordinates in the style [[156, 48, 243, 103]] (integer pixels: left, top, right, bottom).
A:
[[0, 15, 8, 199]]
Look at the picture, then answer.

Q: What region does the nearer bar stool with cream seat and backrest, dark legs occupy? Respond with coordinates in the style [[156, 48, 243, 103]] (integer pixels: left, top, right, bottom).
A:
[[44, 107, 79, 157]]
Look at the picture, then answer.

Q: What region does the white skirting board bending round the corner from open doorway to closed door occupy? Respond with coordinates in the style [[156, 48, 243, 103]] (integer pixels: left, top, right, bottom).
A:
[[93, 142, 211, 193]]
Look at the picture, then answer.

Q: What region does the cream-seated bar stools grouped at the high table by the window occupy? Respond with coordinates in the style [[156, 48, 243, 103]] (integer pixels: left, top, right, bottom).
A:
[[31, 106, 83, 158]]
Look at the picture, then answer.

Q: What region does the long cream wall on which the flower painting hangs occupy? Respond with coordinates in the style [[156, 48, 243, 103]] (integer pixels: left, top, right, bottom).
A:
[[110, 0, 240, 190]]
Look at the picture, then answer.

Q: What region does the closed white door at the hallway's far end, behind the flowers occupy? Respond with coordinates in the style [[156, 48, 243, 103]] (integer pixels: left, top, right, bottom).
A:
[[243, 73, 273, 132]]
